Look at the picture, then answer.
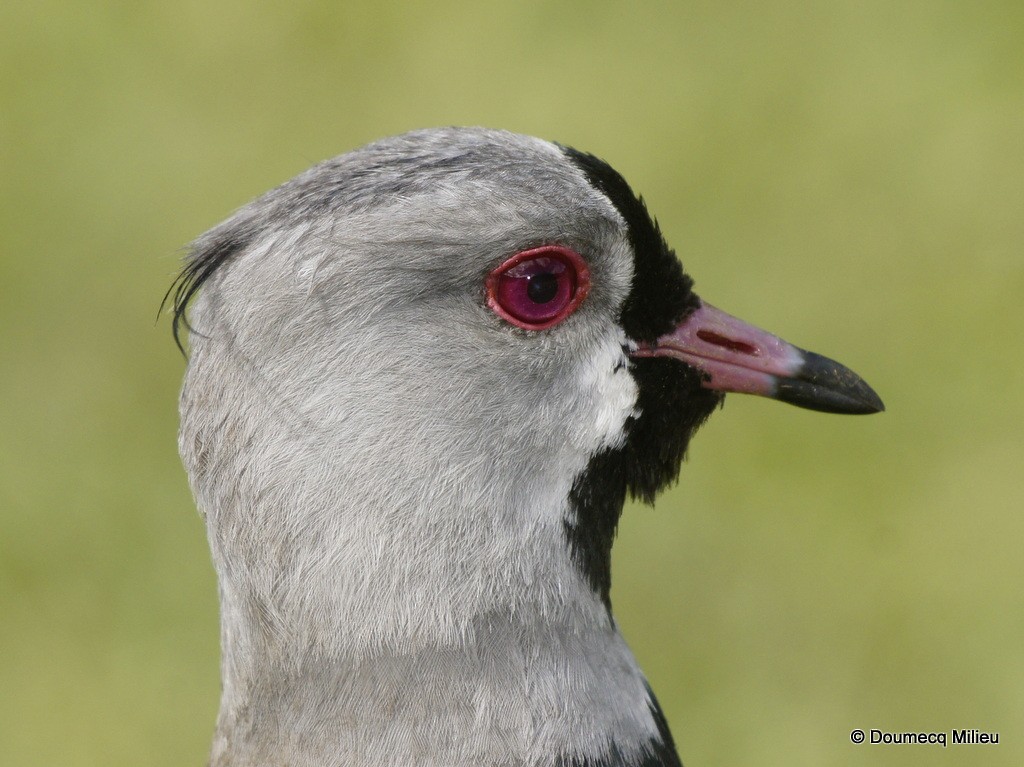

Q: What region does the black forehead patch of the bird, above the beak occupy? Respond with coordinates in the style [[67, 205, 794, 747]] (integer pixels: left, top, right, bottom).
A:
[[561, 146, 700, 343]]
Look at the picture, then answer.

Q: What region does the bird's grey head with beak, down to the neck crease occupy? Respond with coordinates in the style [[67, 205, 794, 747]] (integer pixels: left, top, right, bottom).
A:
[[167, 128, 882, 645]]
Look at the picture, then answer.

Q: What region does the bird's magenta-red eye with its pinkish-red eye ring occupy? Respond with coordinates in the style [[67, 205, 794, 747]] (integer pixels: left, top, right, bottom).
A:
[[486, 245, 590, 330]]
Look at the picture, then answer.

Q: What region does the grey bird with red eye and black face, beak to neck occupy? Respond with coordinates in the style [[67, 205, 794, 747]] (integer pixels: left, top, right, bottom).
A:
[[165, 127, 884, 767]]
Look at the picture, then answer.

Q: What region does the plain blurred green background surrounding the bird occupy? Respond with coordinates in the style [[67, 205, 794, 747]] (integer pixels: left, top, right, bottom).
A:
[[0, 0, 1024, 767]]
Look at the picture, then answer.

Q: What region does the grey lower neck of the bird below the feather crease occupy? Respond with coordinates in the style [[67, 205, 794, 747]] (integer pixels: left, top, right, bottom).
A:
[[211, 609, 658, 767]]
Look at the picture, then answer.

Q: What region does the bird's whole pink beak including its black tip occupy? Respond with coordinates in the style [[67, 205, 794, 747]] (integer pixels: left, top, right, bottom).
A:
[[633, 303, 885, 414]]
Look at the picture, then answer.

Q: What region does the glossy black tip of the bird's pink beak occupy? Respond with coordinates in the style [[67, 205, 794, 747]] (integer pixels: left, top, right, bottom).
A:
[[775, 350, 886, 416]]
